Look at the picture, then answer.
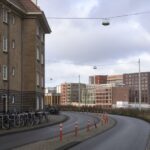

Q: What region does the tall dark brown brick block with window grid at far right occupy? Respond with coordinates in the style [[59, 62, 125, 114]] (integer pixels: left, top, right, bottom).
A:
[[123, 72, 150, 104]]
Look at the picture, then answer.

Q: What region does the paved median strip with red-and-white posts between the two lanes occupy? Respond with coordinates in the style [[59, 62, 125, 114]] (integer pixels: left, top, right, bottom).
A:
[[13, 114, 116, 150]]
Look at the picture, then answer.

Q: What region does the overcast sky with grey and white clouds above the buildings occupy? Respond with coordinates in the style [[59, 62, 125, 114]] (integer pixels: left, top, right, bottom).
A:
[[38, 0, 150, 86]]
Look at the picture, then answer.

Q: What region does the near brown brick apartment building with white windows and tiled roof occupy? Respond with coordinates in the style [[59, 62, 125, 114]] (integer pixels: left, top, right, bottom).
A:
[[0, 0, 51, 112]]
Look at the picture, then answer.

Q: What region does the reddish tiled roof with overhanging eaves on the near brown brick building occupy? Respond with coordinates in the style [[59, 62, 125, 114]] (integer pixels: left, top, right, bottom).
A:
[[7, 0, 51, 33]]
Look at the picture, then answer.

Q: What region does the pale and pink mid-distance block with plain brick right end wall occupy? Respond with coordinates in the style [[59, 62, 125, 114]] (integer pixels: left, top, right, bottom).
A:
[[82, 84, 129, 108]]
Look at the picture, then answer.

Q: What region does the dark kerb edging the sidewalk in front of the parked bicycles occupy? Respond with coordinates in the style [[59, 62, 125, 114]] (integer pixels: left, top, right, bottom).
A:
[[0, 115, 69, 137]]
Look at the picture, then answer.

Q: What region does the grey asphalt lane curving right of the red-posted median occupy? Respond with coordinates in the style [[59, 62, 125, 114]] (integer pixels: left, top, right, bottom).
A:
[[71, 116, 150, 150]]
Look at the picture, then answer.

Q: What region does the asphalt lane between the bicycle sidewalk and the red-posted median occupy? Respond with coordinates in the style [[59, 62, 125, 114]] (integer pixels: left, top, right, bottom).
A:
[[0, 112, 98, 150]]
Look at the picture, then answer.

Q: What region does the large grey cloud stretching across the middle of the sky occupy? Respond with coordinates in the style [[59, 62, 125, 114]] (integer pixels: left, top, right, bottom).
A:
[[47, 19, 150, 63]]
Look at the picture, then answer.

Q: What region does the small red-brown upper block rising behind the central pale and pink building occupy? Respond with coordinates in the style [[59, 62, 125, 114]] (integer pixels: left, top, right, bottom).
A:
[[89, 75, 107, 84]]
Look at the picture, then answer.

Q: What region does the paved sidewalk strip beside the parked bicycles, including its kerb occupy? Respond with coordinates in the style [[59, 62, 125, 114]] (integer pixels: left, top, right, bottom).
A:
[[0, 114, 68, 136]]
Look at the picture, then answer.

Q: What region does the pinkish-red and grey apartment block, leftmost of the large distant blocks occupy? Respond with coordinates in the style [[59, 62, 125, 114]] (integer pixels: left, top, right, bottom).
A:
[[60, 83, 86, 105]]
